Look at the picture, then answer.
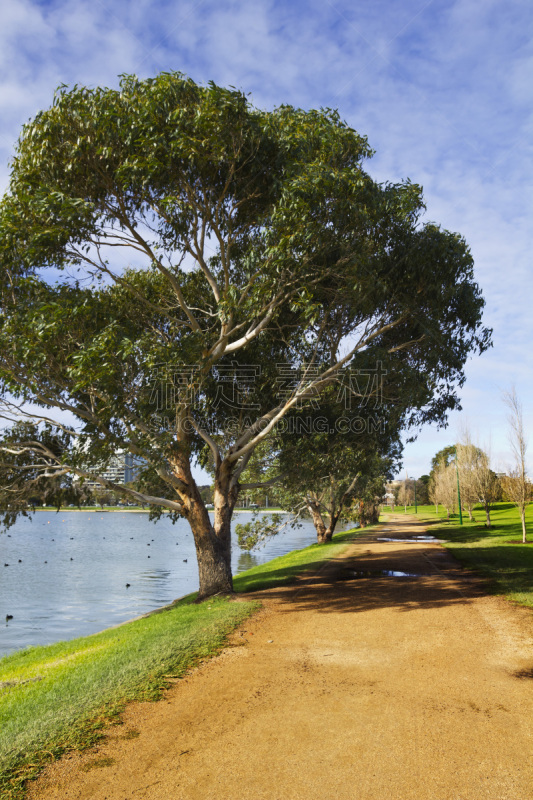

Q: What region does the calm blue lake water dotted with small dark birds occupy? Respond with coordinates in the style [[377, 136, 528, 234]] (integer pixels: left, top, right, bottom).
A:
[[0, 511, 332, 656]]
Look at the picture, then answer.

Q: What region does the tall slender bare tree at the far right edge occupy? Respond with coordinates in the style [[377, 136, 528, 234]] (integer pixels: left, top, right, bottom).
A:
[[501, 386, 532, 543]]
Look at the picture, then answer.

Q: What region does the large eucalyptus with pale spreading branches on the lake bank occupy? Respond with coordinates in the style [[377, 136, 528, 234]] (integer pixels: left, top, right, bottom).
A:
[[0, 73, 490, 598]]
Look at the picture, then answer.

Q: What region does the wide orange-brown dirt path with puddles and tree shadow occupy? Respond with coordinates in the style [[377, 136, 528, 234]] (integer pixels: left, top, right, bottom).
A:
[[30, 517, 533, 800]]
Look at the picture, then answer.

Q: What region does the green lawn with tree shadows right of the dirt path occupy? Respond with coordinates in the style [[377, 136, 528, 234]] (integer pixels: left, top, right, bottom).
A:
[[384, 503, 533, 608]]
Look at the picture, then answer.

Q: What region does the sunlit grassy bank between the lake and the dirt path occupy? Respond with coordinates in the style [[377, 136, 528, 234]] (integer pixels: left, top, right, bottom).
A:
[[0, 532, 362, 800]]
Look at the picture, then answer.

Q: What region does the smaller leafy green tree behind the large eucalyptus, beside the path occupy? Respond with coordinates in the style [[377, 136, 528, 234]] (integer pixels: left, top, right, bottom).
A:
[[237, 392, 402, 546]]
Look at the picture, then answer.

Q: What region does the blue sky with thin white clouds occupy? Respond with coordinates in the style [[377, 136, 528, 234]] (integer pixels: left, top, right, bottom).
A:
[[0, 0, 533, 478]]
